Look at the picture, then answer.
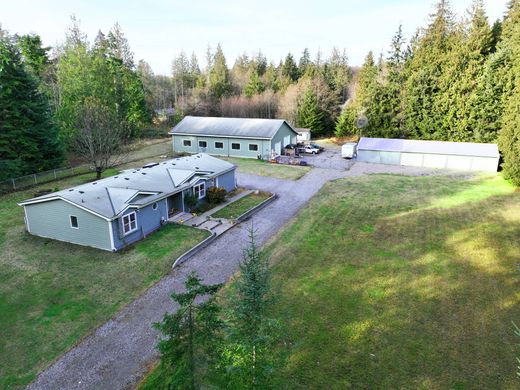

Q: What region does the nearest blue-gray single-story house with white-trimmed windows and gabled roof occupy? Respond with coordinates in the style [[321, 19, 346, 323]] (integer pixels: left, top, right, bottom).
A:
[[19, 154, 236, 251]]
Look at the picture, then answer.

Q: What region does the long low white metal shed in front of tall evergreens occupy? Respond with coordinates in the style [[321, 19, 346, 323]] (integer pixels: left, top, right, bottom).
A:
[[357, 137, 500, 172]]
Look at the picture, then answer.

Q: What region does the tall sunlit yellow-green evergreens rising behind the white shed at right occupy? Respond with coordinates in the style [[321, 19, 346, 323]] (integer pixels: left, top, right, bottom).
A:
[[336, 0, 520, 185]]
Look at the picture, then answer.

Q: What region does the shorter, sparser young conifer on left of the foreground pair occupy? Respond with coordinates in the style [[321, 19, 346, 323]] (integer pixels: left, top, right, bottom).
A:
[[151, 273, 222, 390]]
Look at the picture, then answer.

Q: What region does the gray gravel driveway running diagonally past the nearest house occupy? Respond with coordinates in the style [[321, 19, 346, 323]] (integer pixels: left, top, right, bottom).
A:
[[28, 168, 348, 390]]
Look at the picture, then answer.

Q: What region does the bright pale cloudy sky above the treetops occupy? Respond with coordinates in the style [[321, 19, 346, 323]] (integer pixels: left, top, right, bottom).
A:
[[0, 0, 508, 75]]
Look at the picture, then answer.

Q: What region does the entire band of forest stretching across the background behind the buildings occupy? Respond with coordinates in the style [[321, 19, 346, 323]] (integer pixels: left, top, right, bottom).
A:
[[0, 0, 520, 185]]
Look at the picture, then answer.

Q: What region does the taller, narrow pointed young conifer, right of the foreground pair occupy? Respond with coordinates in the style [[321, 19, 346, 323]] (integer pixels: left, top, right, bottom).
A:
[[221, 227, 283, 389]]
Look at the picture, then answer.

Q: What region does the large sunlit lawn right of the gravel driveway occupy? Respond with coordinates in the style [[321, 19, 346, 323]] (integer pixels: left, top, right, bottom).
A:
[[266, 175, 520, 390]]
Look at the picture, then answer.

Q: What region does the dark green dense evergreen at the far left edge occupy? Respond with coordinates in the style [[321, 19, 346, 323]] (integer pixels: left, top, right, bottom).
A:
[[0, 33, 63, 179]]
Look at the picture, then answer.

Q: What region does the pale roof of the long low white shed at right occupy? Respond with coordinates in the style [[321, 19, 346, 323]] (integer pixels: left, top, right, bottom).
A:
[[357, 137, 500, 158]]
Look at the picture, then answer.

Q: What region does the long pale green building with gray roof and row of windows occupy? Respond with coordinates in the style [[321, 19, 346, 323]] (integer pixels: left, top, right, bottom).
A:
[[169, 116, 298, 160]]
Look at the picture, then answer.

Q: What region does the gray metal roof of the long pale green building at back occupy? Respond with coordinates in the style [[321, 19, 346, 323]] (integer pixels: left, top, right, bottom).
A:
[[169, 116, 297, 139]]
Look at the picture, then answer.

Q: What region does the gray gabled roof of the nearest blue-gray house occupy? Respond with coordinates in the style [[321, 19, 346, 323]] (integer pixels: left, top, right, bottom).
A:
[[20, 153, 235, 219]]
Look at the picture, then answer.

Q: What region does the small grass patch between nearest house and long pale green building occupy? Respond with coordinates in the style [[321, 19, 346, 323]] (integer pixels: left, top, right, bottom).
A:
[[217, 156, 311, 180]]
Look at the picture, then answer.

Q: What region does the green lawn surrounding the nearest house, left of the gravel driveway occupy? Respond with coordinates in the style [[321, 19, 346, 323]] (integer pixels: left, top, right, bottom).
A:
[[0, 170, 207, 389]]
